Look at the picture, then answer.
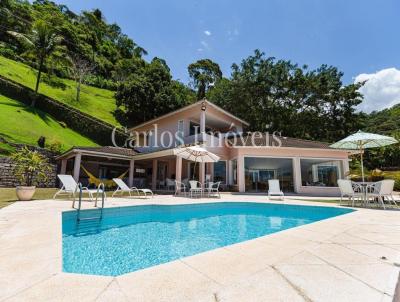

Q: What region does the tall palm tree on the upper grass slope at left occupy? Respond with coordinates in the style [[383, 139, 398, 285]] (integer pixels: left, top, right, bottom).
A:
[[8, 20, 62, 101]]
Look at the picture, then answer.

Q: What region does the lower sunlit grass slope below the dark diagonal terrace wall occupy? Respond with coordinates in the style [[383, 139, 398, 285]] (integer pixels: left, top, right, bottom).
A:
[[0, 95, 96, 151]]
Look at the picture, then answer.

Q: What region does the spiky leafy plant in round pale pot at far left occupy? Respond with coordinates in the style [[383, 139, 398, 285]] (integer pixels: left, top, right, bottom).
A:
[[11, 147, 52, 200]]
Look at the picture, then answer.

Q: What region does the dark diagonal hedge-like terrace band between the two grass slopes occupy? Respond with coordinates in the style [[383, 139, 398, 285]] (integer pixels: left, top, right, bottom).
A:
[[0, 76, 128, 146]]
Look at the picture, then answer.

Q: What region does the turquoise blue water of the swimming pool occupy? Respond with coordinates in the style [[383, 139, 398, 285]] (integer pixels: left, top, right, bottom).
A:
[[62, 202, 352, 276]]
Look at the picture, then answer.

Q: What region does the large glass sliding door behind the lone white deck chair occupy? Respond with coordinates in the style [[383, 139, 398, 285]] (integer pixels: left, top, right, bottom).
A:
[[244, 157, 294, 192]]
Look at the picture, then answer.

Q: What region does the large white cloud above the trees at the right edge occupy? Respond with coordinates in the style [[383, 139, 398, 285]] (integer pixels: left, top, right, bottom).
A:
[[354, 68, 400, 113]]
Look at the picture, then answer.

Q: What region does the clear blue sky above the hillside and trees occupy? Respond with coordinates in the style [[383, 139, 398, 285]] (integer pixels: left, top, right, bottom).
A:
[[56, 0, 400, 111]]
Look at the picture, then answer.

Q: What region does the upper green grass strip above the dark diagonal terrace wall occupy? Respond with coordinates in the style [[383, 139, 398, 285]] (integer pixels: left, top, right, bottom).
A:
[[0, 56, 119, 125]]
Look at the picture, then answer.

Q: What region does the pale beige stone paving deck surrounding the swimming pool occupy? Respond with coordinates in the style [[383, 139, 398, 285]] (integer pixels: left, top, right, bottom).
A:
[[0, 194, 400, 302]]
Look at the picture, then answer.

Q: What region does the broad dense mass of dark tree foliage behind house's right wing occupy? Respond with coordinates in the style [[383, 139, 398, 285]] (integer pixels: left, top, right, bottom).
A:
[[208, 50, 362, 141]]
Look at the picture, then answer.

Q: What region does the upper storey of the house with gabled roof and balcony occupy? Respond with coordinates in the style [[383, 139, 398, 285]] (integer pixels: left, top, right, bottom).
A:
[[129, 100, 249, 148]]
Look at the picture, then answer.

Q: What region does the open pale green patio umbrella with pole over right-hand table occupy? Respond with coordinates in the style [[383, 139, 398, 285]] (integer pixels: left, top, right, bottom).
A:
[[330, 130, 398, 181]]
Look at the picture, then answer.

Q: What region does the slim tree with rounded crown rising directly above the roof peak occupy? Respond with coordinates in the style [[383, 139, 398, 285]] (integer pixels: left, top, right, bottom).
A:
[[188, 59, 222, 100]]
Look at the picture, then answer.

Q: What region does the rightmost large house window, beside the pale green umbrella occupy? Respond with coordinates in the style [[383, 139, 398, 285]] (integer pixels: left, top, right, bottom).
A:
[[300, 159, 341, 187]]
